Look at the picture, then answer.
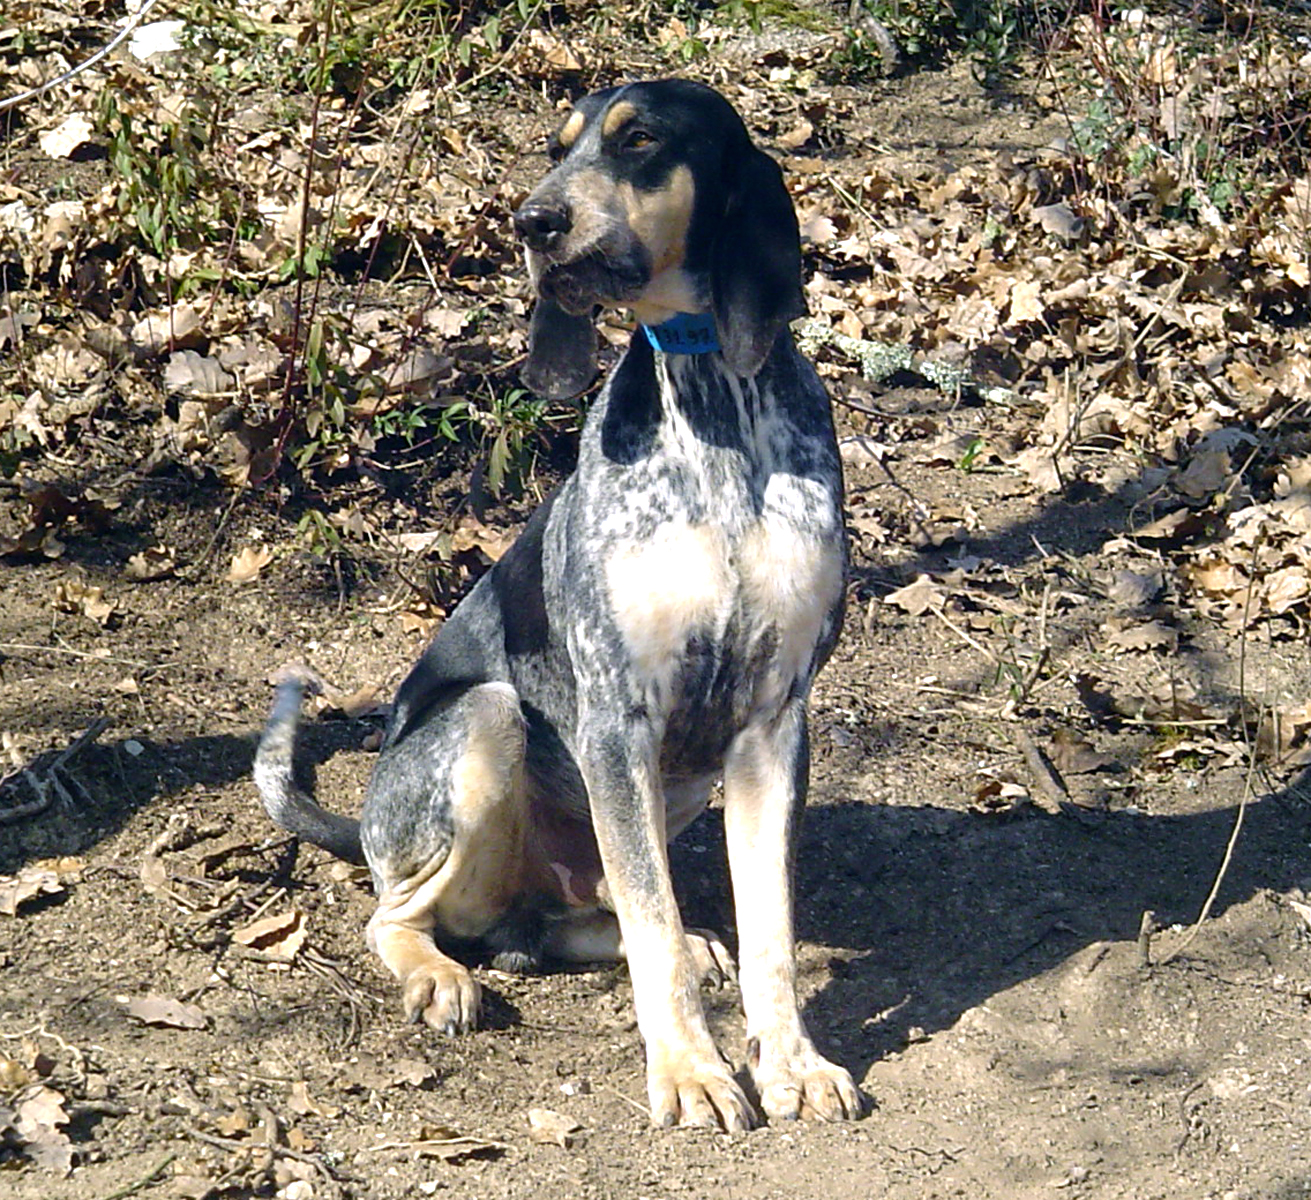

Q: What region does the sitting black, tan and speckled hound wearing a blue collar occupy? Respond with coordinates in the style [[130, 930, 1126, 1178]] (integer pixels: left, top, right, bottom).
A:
[[254, 79, 861, 1130]]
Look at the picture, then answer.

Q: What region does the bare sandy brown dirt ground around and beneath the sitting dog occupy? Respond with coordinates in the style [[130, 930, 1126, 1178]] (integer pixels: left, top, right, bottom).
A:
[[0, 32, 1311, 1200]]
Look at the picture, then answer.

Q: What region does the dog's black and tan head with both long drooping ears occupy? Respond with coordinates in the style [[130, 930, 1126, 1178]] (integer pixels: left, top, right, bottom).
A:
[[514, 79, 805, 399]]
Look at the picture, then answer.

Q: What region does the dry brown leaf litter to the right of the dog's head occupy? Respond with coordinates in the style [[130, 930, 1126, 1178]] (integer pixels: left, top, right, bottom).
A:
[[793, 13, 1311, 647]]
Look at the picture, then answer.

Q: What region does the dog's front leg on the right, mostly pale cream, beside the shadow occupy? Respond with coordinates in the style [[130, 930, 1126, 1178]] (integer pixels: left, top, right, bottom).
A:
[[724, 700, 861, 1121]]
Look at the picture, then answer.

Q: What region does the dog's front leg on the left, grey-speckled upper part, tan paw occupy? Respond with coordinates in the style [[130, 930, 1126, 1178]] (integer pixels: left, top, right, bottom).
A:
[[579, 725, 755, 1130]]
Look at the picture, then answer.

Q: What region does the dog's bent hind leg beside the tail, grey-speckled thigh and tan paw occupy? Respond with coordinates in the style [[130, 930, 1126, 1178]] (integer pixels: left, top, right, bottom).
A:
[[361, 683, 527, 1033]]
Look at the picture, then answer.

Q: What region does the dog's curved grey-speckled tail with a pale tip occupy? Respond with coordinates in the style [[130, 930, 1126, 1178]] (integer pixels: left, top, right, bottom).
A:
[[254, 669, 364, 863]]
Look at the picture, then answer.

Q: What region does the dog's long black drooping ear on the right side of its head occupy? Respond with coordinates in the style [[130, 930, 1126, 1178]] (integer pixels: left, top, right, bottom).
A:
[[711, 146, 806, 378]]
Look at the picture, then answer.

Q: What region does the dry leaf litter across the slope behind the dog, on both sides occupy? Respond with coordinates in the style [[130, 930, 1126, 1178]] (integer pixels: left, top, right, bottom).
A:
[[0, 7, 1311, 632]]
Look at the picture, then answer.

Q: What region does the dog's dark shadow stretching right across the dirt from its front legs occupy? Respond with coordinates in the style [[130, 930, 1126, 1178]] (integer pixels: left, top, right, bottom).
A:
[[671, 787, 1311, 1078]]
